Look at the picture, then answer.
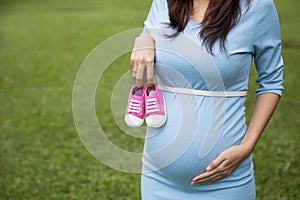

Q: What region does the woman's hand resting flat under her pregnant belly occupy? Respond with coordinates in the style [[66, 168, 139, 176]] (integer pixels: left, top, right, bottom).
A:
[[191, 144, 252, 185]]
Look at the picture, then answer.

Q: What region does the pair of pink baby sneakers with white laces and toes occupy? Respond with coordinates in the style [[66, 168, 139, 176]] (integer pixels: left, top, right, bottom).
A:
[[125, 84, 167, 128]]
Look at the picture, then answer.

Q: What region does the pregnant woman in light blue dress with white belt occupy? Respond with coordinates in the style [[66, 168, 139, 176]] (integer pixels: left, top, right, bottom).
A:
[[130, 0, 283, 200]]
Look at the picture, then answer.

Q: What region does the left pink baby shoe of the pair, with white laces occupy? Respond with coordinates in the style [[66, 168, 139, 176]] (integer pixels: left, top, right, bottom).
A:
[[125, 85, 145, 128]]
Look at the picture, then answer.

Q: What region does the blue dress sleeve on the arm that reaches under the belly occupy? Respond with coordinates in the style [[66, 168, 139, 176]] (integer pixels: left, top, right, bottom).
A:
[[253, 0, 284, 96]]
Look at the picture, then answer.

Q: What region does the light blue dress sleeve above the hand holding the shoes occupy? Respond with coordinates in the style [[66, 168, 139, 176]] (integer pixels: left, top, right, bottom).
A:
[[142, 0, 168, 34]]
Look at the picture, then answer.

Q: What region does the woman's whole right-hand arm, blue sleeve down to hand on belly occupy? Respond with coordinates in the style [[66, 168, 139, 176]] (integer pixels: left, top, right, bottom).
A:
[[191, 0, 283, 184]]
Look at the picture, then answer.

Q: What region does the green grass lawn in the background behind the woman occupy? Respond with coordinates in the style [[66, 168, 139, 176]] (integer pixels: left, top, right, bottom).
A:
[[0, 0, 300, 200]]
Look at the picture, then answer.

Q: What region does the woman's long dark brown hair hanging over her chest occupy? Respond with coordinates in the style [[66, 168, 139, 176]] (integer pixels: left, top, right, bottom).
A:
[[168, 0, 251, 53]]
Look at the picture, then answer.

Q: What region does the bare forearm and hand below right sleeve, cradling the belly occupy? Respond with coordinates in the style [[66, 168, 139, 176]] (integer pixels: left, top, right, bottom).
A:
[[191, 93, 280, 185]]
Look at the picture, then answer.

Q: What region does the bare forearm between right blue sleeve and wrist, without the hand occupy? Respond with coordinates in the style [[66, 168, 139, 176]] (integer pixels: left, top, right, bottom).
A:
[[241, 93, 280, 152]]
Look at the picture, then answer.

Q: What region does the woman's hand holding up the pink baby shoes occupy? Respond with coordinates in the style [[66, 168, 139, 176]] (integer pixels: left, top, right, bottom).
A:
[[130, 35, 155, 87]]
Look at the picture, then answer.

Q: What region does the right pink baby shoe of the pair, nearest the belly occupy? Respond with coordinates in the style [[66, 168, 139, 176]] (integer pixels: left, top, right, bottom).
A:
[[144, 84, 167, 128]]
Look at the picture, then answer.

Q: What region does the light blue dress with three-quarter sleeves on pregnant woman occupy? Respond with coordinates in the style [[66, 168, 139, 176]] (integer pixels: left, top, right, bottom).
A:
[[141, 0, 283, 200]]
